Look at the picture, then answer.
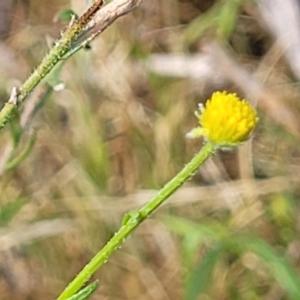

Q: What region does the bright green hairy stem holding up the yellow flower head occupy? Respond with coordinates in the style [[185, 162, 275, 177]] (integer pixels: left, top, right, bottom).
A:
[[57, 142, 216, 300]]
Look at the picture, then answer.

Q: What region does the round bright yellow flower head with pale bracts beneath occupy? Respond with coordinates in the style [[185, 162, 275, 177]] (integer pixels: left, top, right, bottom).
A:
[[188, 91, 258, 147]]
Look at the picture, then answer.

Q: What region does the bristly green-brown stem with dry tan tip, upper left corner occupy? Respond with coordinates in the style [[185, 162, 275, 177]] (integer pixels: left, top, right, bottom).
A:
[[0, 0, 143, 130]]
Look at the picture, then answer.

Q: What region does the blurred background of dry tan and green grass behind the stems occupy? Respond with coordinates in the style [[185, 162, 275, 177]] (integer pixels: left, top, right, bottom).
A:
[[0, 0, 300, 300]]
